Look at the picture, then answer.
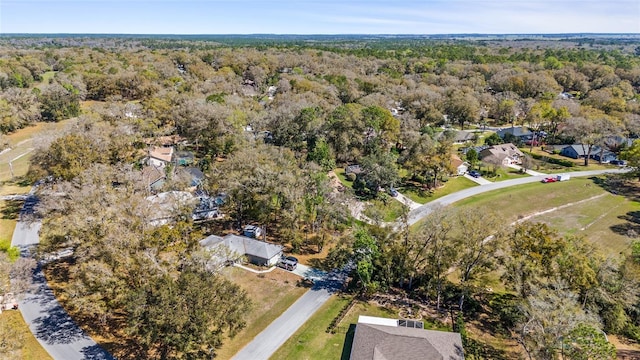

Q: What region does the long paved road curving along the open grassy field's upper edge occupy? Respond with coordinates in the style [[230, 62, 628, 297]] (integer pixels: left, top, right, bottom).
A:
[[408, 169, 629, 226]]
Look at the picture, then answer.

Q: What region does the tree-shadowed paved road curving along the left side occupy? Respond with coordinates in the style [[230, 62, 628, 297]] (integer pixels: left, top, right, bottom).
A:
[[11, 217, 113, 360]]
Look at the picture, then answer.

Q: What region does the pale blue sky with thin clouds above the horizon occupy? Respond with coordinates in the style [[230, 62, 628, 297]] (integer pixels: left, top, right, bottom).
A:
[[0, 0, 640, 34]]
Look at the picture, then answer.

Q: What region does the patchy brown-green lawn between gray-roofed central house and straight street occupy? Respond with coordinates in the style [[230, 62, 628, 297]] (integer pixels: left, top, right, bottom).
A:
[[216, 267, 307, 359]]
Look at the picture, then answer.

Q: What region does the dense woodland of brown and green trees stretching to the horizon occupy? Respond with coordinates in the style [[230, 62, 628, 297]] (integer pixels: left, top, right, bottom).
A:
[[0, 37, 640, 359]]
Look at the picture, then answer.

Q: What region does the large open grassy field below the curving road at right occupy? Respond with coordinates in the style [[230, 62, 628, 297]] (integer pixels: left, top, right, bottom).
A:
[[456, 178, 640, 254]]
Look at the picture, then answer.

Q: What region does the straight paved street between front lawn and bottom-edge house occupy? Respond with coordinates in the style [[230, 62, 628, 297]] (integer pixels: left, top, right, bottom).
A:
[[232, 271, 345, 360]]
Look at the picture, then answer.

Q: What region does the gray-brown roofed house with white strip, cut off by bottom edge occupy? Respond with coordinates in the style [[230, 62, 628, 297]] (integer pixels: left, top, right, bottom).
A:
[[350, 315, 464, 360]]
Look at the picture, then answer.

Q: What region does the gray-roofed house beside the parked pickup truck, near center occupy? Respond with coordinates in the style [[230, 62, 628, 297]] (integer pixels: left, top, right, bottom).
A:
[[200, 234, 283, 266]]
